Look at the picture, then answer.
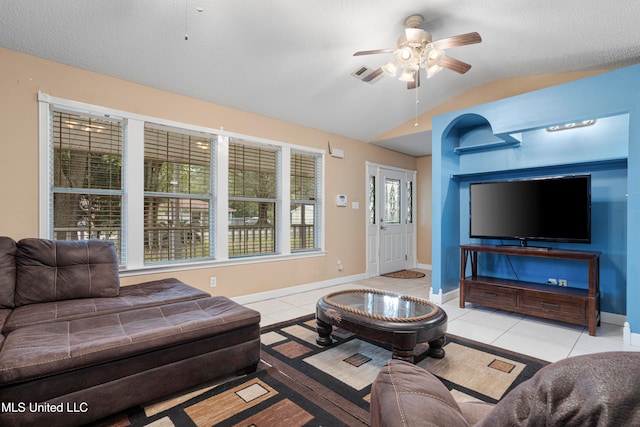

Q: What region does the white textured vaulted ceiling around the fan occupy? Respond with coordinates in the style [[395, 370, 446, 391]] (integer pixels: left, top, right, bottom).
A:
[[0, 0, 640, 155]]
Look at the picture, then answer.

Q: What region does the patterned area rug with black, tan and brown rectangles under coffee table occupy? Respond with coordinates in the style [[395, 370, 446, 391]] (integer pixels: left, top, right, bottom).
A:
[[99, 315, 547, 427]]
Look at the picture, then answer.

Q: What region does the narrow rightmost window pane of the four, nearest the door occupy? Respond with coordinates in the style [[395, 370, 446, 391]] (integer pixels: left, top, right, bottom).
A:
[[290, 152, 320, 251]]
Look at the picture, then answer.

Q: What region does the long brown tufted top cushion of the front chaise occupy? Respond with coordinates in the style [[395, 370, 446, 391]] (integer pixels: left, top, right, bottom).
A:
[[0, 297, 260, 384]]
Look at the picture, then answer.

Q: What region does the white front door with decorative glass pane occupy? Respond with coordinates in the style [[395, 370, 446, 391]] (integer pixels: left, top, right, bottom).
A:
[[378, 169, 407, 274]]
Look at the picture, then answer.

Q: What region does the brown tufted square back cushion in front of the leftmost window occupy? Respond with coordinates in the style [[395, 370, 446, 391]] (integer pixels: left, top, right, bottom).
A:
[[15, 238, 120, 307]]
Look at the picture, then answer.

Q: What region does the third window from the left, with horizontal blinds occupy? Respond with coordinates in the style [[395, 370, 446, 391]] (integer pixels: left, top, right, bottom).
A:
[[229, 139, 278, 257]]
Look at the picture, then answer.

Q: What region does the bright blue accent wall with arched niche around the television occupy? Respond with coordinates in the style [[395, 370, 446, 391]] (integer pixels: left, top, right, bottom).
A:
[[432, 65, 640, 333]]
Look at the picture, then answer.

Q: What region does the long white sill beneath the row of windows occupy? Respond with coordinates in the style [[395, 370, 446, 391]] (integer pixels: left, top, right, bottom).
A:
[[120, 250, 327, 277]]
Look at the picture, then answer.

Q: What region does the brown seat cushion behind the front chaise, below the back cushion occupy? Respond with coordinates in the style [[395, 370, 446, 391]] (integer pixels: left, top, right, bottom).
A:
[[5, 278, 211, 333]]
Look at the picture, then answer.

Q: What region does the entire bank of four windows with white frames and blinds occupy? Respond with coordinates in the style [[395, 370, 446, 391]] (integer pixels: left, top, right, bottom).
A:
[[38, 93, 324, 271]]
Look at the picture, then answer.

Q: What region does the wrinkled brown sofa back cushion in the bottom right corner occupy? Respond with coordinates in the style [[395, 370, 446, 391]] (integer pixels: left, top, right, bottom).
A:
[[477, 352, 640, 427]]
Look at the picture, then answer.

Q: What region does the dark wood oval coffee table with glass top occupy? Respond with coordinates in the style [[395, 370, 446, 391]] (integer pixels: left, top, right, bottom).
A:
[[316, 289, 447, 362]]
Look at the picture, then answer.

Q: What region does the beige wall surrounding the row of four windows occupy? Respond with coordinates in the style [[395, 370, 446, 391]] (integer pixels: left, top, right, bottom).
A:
[[0, 49, 416, 296]]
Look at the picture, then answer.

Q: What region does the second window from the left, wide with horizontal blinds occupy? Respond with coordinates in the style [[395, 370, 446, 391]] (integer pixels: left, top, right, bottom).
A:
[[144, 126, 213, 262]]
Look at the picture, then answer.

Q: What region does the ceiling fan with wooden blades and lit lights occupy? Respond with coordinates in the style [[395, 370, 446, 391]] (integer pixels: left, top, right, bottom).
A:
[[353, 15, 482, 89]]
